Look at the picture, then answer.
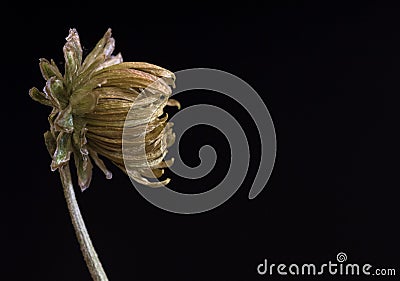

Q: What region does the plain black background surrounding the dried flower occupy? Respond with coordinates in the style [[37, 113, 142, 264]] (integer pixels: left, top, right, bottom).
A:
[[0, 1, 400, 281]]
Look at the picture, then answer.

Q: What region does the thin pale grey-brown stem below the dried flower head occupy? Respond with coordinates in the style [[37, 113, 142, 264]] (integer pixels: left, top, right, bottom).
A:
[[59, 164, 108, 281]]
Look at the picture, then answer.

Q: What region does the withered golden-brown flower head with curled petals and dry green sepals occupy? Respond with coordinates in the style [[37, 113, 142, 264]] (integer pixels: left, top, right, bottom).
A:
[[29, 29, 180, 190]]
